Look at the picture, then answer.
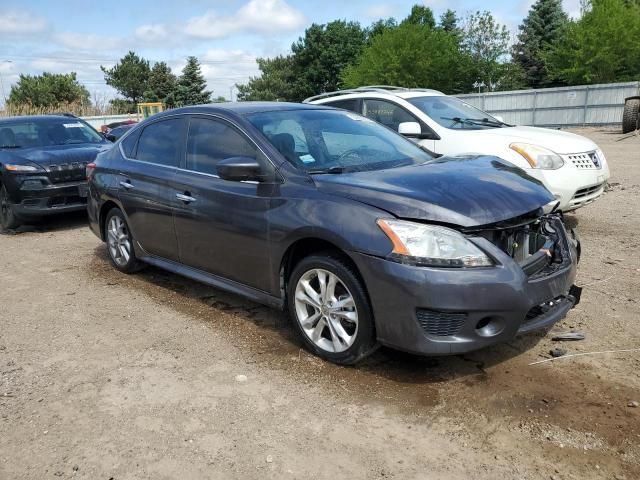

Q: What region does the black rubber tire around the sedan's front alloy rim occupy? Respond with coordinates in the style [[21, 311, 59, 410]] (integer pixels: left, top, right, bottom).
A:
[[287, 252, 378, 365]]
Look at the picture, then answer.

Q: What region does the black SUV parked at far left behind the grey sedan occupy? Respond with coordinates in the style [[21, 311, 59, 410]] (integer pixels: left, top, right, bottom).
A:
[[0, 115, 112, 229]]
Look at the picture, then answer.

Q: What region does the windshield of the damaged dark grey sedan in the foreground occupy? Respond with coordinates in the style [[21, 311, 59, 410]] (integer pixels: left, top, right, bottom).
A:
[[247, 110, 433, 173]]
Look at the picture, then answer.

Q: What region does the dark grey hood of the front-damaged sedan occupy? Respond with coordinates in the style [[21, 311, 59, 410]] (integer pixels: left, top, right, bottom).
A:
[[313, 156, 554, 227]]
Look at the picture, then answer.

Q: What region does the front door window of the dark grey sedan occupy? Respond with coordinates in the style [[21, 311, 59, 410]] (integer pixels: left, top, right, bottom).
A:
[[186, 117, 258, 175]]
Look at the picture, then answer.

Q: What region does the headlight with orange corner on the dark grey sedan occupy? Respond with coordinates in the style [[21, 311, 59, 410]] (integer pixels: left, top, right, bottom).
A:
[[378, 219, 493, 267]]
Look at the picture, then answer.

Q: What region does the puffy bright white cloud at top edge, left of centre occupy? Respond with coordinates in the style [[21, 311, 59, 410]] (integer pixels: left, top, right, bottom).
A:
[[185, 0, 306, 38]]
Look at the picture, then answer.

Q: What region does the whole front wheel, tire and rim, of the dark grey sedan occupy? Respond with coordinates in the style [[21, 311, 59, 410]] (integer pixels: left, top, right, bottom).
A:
[[287, 253, 377, 365]]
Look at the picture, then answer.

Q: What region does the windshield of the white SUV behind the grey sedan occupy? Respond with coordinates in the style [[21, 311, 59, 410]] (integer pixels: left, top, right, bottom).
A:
[[407, 96, 508, 130]]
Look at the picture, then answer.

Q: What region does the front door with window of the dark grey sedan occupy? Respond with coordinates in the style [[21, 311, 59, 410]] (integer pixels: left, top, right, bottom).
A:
[[172, 116, 271, 291]]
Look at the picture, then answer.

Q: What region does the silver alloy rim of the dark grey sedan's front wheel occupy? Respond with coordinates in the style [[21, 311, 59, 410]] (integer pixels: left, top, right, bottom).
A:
[[295, 268, 358, 353]]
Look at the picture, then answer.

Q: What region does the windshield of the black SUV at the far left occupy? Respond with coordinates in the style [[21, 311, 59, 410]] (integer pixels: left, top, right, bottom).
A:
[[0, 118, 104, 148]]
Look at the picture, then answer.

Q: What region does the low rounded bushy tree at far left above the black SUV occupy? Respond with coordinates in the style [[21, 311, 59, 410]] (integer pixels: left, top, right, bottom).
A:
[[8, 72, 91, 108]]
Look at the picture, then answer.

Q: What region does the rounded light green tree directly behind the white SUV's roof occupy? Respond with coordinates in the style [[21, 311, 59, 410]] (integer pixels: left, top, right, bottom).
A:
[[342, 22, 471, 93]]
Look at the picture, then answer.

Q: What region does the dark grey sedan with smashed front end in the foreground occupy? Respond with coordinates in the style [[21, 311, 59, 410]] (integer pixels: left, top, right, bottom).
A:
[[88, 103, 578, 364]]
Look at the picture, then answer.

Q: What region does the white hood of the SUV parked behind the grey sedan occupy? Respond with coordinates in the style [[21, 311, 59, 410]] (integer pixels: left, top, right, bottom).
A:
[[472, 126, 598, 154]]
